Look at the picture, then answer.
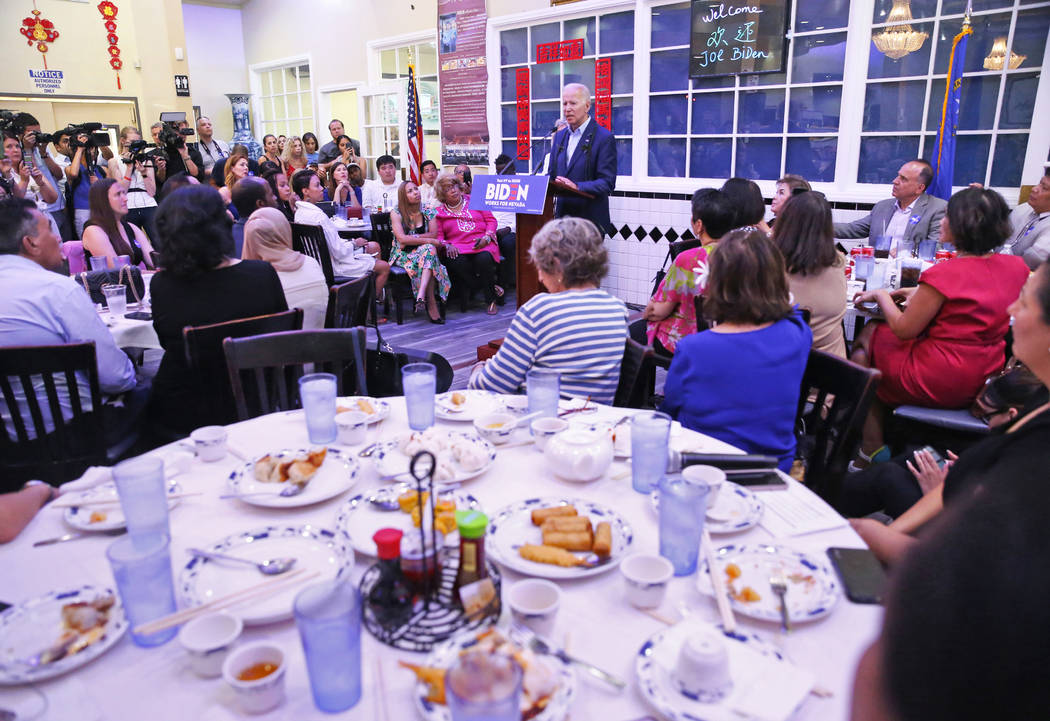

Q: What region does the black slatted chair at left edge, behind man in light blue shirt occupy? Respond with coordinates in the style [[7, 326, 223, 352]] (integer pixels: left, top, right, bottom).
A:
[[0, 341, 107, 492]]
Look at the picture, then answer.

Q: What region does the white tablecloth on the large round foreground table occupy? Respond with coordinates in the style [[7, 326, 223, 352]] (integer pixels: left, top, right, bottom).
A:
[[0, 399, 882, 721]]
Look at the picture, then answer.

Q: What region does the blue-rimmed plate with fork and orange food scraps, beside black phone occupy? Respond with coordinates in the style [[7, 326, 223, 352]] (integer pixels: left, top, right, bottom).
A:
[[696, 544, 842, 623]]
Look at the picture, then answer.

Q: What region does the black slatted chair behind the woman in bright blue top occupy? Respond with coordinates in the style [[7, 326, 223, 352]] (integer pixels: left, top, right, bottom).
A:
[[795, 349, 882, 506]]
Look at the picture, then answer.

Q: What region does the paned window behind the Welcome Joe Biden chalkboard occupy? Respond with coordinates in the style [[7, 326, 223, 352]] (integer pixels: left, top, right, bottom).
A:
[[648, 0, 849, 182]]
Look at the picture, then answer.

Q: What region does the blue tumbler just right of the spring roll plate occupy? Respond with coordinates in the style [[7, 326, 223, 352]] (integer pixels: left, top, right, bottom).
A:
[[659, 476, 710, 576]]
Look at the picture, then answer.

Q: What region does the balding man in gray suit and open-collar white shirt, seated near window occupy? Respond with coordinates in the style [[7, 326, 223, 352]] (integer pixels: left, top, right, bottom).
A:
[[835, 160, 948, 255]]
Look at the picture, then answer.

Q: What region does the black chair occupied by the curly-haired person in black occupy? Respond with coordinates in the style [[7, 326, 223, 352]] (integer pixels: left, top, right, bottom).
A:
[[180, 308, 302, 430]]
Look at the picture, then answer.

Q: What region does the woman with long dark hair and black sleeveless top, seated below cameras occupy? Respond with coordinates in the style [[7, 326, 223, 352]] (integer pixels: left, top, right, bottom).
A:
[[84, 177, 153, 269]]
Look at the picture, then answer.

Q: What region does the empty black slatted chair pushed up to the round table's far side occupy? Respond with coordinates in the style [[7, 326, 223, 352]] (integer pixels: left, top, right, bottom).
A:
[[223, 327, 369, 421]]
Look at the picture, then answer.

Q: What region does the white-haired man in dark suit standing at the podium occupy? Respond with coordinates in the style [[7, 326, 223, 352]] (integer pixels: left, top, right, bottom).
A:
[[549, 83, 616, 234]]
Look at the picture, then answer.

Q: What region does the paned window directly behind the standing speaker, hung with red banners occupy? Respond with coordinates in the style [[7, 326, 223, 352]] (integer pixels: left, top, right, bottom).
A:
[[500, 10, 634, 175]]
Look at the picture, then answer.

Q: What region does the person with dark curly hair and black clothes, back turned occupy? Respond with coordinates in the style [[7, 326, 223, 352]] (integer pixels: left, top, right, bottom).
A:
[[149, 186, 288, 434]]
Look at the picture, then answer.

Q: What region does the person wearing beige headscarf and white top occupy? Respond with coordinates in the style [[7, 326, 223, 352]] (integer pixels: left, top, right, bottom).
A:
[[243, 205, 329, 330]]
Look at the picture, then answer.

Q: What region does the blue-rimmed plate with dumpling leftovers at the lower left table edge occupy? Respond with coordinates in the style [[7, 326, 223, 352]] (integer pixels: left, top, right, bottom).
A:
[[0, 586, 128, 685]]
